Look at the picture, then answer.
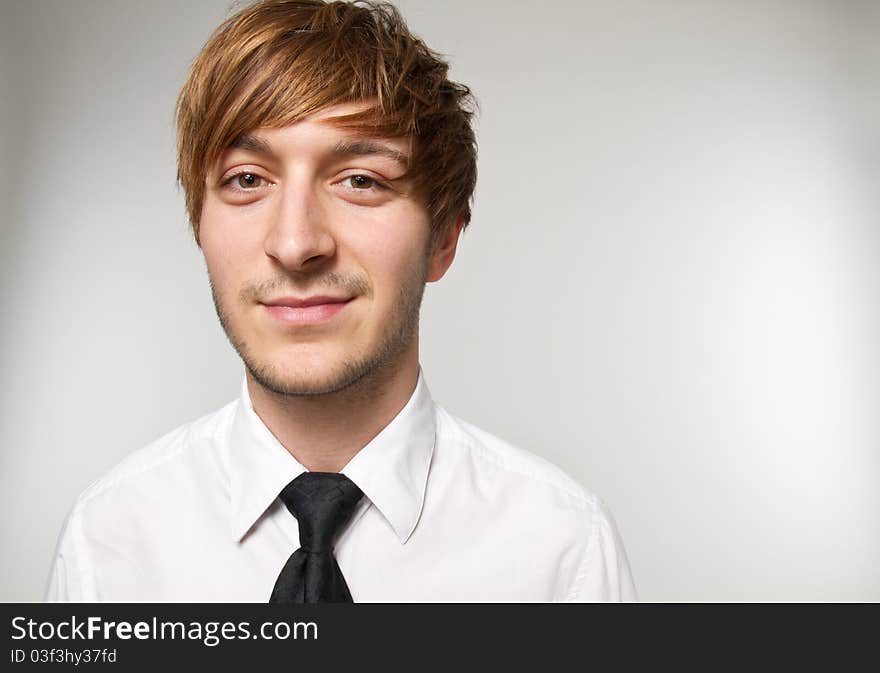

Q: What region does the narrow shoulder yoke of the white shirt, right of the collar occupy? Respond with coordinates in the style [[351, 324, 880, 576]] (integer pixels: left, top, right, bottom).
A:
[[435, 404, 604, 512]]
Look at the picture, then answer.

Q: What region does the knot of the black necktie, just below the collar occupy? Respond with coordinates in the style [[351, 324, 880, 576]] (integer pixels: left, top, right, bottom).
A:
[[279, 472, 363, 552]]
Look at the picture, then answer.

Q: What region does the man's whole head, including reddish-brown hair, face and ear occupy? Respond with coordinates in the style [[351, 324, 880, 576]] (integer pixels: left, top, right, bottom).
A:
[[178, 0, 476, 394]]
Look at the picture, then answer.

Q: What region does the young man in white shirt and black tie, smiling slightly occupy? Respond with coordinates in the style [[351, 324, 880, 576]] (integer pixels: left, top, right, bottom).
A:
[[47, 0, 635, 602]]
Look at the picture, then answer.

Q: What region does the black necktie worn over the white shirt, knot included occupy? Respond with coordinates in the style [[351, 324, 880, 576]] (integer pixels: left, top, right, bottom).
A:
[[269, 472, 363, 603]]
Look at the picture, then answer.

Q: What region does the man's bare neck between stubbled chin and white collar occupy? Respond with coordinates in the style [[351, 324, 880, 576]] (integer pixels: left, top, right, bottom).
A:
[[247, 347, 419, 472]]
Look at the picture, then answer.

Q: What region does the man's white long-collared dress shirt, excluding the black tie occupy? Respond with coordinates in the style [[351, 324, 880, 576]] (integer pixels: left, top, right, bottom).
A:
[[46, 370, 636, 603]]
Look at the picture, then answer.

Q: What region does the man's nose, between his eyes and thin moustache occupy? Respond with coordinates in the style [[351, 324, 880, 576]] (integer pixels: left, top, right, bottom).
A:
[[263, 182, 336, 271]]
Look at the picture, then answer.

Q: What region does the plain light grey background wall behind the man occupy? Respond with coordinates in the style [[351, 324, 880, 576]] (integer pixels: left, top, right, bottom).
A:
[[0, 0, 880, 601]]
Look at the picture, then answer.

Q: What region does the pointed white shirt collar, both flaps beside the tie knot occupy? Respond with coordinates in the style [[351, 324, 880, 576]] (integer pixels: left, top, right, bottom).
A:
[[228, 367, 436, 544]]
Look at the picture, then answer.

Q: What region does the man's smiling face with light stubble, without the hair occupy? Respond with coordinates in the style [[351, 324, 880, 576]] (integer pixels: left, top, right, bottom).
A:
[[200, 104, 454, 395]]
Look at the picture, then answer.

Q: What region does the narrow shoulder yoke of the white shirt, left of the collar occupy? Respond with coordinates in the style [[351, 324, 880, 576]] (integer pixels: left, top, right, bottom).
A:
[[74, 399, 238, 510]]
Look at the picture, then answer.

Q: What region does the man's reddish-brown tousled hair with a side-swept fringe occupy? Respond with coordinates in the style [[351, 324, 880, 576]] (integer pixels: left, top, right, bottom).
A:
[[177, 0, 477, 249]]
